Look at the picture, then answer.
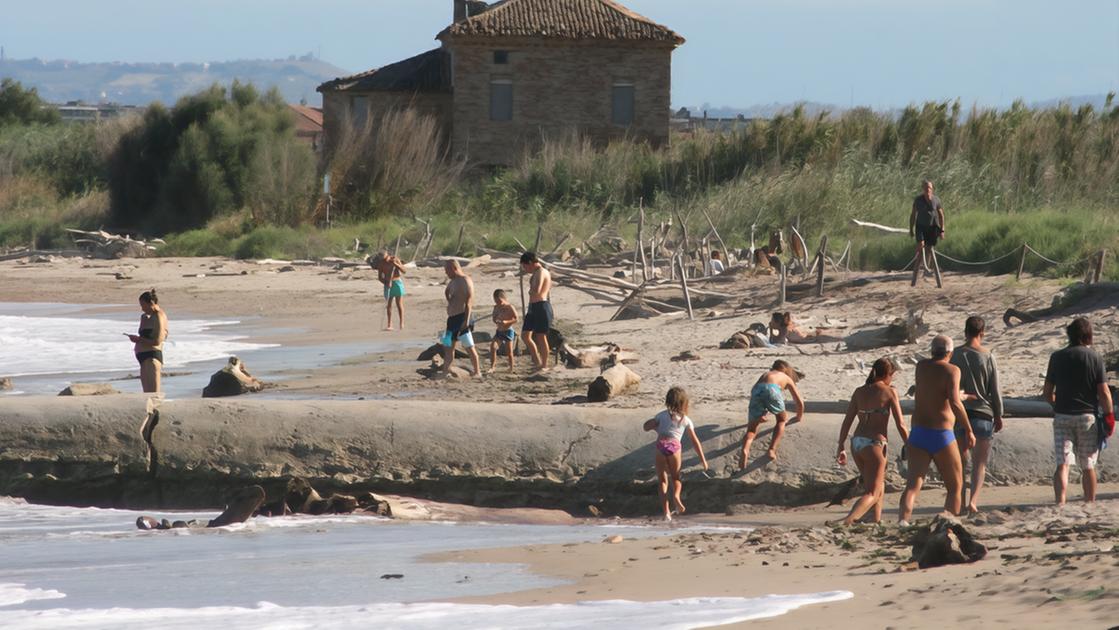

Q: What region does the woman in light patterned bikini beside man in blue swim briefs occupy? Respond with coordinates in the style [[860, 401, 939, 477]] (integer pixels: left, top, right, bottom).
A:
[[836, 358, 909, 525]]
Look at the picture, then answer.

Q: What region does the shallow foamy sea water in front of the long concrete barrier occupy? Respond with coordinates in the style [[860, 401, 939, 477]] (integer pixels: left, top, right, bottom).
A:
[[0, 498, 852, 630]]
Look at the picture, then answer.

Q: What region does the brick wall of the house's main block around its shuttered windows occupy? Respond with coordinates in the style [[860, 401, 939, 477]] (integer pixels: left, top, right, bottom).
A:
[[451, 40, 673, 164]]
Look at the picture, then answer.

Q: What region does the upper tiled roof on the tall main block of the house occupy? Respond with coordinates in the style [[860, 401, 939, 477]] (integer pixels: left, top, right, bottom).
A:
[[438, 0, 684, 46]]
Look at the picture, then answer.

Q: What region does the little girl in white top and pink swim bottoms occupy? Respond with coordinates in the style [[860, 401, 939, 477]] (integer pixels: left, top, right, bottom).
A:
[[645, 387, 707, 520]]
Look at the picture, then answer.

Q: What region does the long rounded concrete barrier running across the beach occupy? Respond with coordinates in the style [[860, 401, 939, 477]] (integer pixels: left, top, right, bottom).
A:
[[0, 394, 1119, 516]]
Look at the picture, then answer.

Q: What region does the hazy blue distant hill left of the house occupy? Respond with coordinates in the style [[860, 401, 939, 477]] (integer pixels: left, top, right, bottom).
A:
[[0, 55, 351, 105]]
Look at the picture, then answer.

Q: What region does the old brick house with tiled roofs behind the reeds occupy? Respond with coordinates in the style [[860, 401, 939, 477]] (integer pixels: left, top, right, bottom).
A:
[[319, 0, 684, 164]]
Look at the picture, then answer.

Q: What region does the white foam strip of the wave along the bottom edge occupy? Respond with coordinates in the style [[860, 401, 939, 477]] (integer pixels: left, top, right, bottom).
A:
[[0, 591, 853, 630]]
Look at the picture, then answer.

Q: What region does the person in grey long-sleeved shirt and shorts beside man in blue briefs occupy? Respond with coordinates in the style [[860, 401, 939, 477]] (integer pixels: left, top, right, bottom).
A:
[[950, 316, 1003, 514]]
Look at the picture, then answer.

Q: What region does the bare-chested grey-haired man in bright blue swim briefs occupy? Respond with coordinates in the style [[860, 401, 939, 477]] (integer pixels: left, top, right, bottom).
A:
[[897, 335, 976, 525]]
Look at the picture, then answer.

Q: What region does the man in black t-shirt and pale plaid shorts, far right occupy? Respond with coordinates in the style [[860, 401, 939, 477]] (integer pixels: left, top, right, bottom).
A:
[[1042, 318, 1116, 506]]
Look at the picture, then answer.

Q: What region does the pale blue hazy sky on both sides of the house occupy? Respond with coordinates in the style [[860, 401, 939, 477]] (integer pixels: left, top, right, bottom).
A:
[[0, 0, 1119, 107]]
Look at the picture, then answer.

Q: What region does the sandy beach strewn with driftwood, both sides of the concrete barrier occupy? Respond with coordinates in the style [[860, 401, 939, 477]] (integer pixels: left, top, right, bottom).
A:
[[0, 254, 1119, 628]]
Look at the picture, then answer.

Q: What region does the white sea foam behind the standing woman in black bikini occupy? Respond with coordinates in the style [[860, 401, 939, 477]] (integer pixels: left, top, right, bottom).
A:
[[0, 313, 270, 376]]
